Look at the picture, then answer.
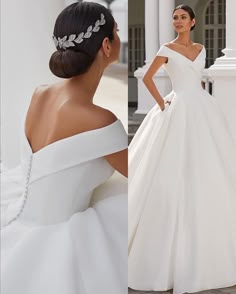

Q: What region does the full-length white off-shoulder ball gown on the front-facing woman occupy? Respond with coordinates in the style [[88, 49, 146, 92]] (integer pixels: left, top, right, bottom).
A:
[[128, 45, 236, 294]]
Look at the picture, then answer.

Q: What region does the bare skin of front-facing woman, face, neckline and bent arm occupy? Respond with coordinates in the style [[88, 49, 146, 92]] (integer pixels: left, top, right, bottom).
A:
[[143, 9, 203, 111]]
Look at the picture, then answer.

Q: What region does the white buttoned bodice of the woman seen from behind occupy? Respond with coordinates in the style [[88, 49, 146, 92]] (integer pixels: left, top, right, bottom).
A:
[[6, 120, 127, 224]]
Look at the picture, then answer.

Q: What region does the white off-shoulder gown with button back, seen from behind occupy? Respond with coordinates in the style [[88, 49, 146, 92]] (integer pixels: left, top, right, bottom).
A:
[[1, 120, 128, 294]]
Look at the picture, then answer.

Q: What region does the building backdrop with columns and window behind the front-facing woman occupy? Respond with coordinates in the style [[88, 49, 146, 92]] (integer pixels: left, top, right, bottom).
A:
[[128, 0, 236, 141]]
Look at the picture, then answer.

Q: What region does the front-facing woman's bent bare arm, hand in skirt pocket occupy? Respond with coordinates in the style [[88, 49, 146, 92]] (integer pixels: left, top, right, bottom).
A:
[[143, 56, 168, 111]]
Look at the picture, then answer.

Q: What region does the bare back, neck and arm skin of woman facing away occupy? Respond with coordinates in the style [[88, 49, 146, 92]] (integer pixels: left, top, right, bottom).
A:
[[25, 24, 128, 177]]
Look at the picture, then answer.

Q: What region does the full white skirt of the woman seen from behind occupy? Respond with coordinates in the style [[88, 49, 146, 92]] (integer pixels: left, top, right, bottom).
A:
[[1, 167, 127, 294]]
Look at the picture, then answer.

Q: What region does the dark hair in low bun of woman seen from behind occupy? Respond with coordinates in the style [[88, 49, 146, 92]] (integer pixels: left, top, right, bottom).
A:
[[49, 2, 115, 78]]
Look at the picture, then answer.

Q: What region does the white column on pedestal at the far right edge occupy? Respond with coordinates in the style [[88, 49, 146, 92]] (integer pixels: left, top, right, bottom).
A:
[[208, 0, 236, 139]]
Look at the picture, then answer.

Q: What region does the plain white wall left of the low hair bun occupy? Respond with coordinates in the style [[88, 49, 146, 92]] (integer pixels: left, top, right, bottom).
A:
[[1, 0, 65, 167]]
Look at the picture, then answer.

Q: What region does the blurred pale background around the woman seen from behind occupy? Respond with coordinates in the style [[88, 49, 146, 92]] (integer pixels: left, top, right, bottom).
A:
[[1, 0, 128, 167]]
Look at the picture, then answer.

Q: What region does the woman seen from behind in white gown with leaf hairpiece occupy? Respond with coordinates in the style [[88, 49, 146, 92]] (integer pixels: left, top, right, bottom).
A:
[[1, 2, 127, 294]]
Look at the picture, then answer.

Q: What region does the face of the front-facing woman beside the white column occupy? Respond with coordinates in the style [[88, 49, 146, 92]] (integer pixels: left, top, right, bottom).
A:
[[173, 9, 195, 33]]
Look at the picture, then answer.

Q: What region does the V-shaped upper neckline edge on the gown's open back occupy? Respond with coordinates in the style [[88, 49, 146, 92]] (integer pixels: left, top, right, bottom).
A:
[[23, 119, 120, 156]]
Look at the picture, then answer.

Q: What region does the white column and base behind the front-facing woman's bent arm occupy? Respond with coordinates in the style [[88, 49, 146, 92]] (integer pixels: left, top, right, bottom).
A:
[[135, 0, 175, 117]]
